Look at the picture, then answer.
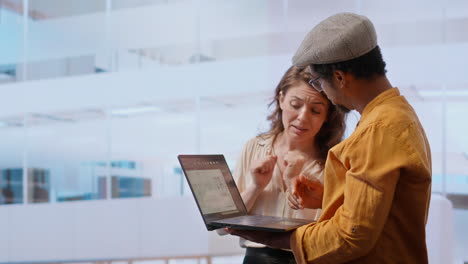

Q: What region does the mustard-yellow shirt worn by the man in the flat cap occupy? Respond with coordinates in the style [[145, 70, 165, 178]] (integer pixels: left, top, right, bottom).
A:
[[291, 88, 432, 263]]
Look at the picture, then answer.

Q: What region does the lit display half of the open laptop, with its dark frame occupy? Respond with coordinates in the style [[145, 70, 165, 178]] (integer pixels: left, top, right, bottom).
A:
[[179, 155, 246, 221]]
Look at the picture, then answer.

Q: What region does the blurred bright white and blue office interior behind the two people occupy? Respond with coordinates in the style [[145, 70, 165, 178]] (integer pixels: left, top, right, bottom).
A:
[[0, 0, 468, 264]]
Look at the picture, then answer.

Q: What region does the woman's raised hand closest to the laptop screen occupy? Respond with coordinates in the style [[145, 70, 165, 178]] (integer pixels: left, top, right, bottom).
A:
[[250, 155, 277, 190]]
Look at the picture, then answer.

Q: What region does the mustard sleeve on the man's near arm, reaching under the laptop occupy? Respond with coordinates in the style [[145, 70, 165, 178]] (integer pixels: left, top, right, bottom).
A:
[[291, 125, 408, 263]]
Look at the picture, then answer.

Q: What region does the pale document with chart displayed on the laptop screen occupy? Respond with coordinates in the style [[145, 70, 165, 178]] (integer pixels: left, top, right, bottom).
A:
[[187, 169, 237, 214]]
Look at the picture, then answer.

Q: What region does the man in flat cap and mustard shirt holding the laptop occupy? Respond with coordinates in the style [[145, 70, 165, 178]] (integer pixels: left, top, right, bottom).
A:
[[229, 13, 431, 263]]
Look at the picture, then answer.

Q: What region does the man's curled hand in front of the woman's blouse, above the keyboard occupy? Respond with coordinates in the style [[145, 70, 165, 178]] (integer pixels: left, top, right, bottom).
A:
[[288, 175, 323, 210]]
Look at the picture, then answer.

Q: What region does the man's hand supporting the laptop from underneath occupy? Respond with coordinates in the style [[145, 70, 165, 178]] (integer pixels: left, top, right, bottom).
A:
[[225, 228, 293, 249]]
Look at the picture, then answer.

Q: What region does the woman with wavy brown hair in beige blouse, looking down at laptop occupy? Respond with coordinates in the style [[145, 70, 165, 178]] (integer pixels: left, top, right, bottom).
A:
[[234, 67, 345, 264]]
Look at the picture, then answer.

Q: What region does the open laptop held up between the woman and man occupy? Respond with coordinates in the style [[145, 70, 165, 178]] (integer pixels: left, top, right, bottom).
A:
[[178, 155, 313, 232]]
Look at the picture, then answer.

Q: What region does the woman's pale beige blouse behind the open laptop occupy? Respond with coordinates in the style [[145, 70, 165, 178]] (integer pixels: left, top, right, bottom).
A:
[[234, 137, 323, 247]]
